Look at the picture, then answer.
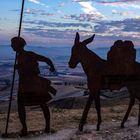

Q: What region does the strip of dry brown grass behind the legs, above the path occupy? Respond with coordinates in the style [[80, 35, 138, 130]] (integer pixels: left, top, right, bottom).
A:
[[0, 98, 138, 132]]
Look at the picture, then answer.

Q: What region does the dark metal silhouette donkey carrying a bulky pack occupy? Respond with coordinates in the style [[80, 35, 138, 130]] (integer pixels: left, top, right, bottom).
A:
[[69, 33, 140, 131]]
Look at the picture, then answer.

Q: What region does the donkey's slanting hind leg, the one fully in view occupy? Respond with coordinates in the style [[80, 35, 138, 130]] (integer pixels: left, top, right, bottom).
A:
[[121, 98, 135, 128]]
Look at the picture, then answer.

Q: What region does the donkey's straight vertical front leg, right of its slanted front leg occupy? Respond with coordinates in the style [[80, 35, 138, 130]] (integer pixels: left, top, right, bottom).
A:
[[95, 95, 102, 131]]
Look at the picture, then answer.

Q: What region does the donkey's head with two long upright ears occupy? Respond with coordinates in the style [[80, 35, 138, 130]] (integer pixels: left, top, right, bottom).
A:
[[69, 32, 95, 68]]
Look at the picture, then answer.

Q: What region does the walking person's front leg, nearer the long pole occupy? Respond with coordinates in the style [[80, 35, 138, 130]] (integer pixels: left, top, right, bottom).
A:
[[18, 94, 27, 136]]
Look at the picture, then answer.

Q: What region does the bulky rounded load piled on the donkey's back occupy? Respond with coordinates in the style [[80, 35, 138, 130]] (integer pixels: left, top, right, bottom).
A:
[[107, 40, 136, 75]]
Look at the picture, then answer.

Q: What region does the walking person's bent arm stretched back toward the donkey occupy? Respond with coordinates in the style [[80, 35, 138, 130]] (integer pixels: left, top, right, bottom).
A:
[[35, 54, 55, 72]]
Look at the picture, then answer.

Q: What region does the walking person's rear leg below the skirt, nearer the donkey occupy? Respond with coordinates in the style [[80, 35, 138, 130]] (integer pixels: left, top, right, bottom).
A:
[[40, 103, 50, 133]]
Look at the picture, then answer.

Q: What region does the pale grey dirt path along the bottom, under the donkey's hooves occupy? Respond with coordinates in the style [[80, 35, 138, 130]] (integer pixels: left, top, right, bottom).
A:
[[1, 117, 140, 140]]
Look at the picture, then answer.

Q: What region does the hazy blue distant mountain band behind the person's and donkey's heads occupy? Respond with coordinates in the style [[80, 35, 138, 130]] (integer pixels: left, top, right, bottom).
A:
[[0, 45, 140, 62]]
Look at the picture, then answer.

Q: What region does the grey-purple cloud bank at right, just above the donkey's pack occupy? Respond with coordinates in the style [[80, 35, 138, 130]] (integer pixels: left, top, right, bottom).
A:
[[94, 18, 140, 38]]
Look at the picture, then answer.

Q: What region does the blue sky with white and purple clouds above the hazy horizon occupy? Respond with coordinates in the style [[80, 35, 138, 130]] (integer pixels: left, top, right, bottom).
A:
[[0, 0, 140, 47]]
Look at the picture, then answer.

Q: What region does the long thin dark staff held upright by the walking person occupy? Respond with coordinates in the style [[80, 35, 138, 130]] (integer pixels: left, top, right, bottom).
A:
[[4, 0, 25, 137]]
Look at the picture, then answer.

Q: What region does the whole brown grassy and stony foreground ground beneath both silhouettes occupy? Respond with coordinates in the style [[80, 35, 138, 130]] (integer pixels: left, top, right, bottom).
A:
[[0, 99, 140, 140]]
